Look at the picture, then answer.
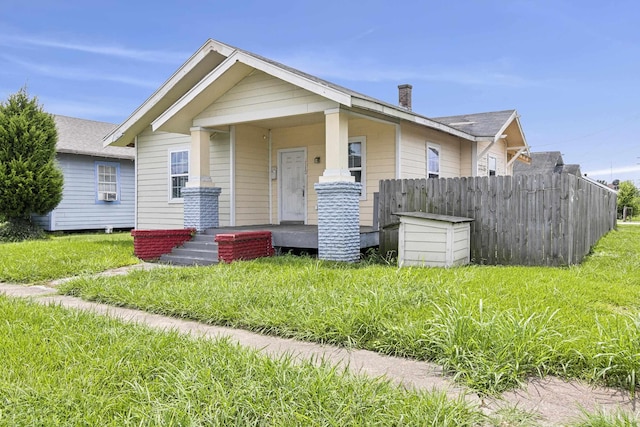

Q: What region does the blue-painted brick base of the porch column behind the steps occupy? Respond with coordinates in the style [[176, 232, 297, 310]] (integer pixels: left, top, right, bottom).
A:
[[182, 187, 222, 231]]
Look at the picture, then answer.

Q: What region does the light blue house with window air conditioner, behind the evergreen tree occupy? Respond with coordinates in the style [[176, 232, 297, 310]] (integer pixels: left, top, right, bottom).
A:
[[33, 116, 135, 231]]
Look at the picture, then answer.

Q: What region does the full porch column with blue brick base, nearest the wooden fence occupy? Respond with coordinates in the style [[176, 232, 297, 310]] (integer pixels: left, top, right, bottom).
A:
[[314, 108, 361, 262]]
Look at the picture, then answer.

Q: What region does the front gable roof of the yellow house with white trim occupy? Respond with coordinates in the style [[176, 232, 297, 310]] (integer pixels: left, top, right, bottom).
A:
[[104, 39, 496, 146]]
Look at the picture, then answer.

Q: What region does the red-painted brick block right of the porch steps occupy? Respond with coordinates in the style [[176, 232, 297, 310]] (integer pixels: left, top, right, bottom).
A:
[[216, 231, 275, 262]]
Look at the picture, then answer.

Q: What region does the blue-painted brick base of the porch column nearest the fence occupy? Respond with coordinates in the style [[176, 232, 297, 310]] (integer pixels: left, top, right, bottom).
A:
[[314, 181, 362, 262]]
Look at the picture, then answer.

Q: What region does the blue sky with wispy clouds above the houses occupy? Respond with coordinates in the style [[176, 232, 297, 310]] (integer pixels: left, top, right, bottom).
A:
[[0, 0, 640, 185]]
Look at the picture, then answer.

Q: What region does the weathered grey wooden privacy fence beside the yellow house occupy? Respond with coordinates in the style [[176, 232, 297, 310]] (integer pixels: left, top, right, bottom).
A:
[[378, 174, 616, 266]]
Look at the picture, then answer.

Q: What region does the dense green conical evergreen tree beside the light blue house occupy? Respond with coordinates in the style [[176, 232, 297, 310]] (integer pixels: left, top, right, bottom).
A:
[[0, 88, 63, 222]]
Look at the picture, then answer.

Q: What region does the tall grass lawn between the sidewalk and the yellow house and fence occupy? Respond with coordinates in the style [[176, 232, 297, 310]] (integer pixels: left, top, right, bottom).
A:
[[60, 227, 640, 393]]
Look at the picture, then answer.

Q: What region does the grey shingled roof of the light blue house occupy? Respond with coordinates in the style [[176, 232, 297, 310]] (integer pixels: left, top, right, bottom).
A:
[[53, 115, 135, 159]]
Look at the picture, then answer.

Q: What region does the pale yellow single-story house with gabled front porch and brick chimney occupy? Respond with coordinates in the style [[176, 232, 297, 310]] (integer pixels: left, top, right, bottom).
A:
[[105, 40, 529, 260]]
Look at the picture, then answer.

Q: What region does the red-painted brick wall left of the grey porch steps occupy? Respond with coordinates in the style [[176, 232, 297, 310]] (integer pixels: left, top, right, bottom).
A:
[[131, 228, 196, 261]]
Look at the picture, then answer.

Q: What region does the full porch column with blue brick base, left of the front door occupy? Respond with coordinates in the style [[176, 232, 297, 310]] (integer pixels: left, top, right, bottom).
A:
[[182, 127, 222, 231]]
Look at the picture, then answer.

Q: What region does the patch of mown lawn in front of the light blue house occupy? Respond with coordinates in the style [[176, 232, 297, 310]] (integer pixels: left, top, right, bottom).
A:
[[0, 233, 139, 283]]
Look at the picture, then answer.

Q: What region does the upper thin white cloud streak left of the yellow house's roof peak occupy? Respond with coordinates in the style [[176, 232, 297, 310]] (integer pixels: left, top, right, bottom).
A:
[[0, 34, 189, 64]]
